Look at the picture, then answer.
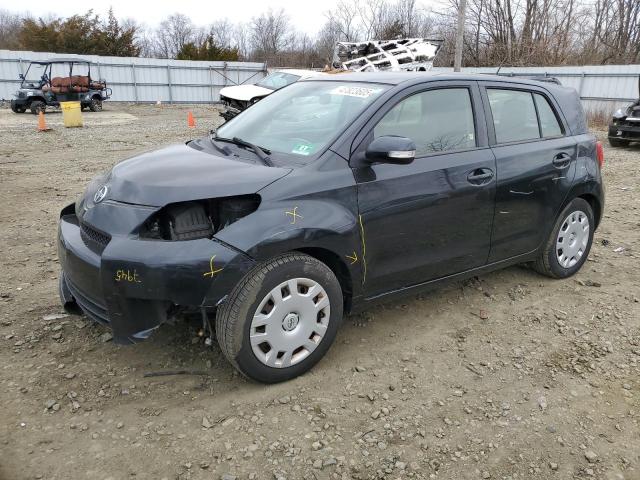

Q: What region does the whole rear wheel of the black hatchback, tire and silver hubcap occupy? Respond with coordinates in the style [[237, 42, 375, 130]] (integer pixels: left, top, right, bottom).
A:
[[534, 198, 595, 278]]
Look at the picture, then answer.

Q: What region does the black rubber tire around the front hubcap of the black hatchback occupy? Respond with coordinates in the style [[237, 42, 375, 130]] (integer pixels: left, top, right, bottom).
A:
[[216, 252, 343, 383]]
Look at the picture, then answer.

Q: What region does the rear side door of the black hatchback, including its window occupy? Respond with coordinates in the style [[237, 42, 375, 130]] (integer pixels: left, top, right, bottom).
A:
[[481, 82, 577, 263]]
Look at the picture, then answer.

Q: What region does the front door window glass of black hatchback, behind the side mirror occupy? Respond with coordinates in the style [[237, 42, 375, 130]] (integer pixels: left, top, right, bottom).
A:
[[373, 88, 476, 157]]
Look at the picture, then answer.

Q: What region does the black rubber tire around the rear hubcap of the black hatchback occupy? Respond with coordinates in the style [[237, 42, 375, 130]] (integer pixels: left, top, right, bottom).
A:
[[533, 198, 595, 278]]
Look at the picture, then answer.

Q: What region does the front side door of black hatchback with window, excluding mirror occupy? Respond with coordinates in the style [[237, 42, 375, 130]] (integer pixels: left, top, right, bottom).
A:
[[354, 82, 496, 297]]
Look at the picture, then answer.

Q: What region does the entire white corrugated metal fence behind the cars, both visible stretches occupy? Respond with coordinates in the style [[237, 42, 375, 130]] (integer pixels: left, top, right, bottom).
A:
[[0, 50, 640, 111]]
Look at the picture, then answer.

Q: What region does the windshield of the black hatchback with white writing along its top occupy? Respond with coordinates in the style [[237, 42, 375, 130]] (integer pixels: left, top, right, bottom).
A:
[[216, 81, 389, 161]]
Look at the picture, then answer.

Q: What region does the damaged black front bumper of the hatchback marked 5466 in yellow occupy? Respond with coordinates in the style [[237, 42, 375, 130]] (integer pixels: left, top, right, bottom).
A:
[[58, 202, 255, 344]]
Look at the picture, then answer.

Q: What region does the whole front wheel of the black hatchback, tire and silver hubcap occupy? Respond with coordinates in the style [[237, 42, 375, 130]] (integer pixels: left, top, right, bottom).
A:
[[216, 252, 343, 383]]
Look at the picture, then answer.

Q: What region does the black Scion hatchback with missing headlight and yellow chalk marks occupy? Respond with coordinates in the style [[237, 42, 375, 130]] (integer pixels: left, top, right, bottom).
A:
[[58, 73, 604, 382]]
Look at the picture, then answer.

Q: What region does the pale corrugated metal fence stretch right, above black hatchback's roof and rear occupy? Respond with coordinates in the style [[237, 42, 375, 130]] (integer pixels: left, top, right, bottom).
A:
[[432, 65, 640, 111]]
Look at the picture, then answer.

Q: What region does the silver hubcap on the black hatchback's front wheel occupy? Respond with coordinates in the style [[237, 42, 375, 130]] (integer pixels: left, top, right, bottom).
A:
[[249, 278, 331, 368]]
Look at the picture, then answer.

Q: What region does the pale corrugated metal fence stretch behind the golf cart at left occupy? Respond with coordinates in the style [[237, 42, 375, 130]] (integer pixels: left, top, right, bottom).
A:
[[0, 50, 266, 103]]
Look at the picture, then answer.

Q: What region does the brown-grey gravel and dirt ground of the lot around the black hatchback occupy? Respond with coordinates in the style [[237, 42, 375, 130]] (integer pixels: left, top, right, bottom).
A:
[[0, 104, 640, 480]]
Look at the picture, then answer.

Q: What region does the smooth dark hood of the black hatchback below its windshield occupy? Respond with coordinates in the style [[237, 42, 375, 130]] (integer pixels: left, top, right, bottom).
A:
[[102, 144, 291, 207]]
